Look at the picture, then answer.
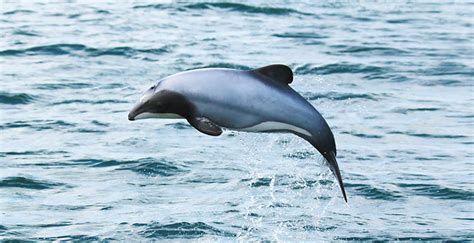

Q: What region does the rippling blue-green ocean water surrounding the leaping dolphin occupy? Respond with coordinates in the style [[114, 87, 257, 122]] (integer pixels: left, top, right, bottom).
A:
[[0, 1, 474, 242]]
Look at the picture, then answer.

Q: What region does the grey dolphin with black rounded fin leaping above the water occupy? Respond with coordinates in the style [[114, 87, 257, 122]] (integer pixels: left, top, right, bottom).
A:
[[128, 64, 347, 203]]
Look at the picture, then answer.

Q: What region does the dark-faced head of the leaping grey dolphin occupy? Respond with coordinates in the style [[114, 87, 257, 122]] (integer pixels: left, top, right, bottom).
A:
[[128, 84, 190, 121]]
